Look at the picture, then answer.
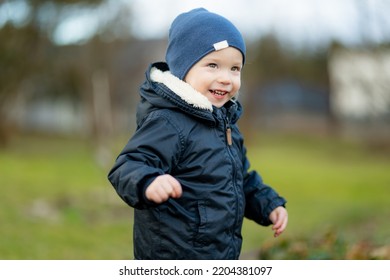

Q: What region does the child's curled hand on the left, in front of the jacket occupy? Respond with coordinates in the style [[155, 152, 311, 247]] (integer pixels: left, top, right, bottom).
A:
[[145, 174, 182, 203]]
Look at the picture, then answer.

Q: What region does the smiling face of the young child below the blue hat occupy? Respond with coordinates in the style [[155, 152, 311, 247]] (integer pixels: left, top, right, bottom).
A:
[[184, 47, 242, 108]]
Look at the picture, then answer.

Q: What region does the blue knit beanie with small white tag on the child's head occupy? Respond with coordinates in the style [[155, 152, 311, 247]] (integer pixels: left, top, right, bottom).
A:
[[165, 8, 246, 80]]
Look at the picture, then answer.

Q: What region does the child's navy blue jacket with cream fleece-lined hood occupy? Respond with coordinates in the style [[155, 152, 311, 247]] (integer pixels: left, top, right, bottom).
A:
[[108, 63, 286, 259]]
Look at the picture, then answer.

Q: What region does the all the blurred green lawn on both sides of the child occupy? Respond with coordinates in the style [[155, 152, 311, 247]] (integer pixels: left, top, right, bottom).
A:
[[0, 132, 390, 259]]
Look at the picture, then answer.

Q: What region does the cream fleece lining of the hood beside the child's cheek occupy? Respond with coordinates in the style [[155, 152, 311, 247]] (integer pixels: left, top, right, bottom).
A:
[[150, 67, 213, 112]]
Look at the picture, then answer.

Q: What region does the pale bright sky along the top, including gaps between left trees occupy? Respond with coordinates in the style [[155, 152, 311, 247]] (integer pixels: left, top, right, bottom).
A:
[[0, 0, 390, 46]]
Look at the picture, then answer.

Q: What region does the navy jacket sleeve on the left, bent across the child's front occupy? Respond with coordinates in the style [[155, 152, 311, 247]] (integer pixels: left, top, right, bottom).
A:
[[108, 112, 181, 209]]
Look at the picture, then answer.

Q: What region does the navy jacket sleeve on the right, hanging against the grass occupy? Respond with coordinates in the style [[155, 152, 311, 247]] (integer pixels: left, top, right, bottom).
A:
[[243, 144, 287, 226]]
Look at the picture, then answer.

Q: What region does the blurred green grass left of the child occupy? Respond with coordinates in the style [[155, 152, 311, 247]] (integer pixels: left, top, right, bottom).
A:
[[0, 137, 132, 259]]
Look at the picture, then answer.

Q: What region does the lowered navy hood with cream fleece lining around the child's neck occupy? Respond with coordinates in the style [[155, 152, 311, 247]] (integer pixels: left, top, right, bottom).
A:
[[137, 62, 242, 126]]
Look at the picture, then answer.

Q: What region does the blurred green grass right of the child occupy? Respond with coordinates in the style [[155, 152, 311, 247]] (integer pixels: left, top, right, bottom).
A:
[[244, 132, 390, 258]]
